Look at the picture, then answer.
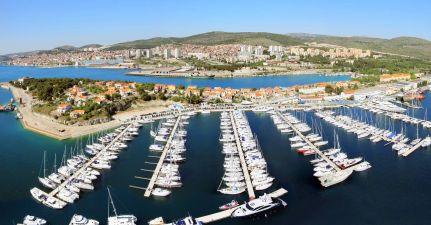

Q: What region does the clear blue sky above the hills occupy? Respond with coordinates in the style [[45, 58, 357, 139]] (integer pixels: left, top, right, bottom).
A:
[[0, 0, 431, 55]]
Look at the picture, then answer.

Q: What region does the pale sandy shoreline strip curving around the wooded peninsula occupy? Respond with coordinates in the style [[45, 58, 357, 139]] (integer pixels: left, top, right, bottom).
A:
[[2, 83, 169, 140]]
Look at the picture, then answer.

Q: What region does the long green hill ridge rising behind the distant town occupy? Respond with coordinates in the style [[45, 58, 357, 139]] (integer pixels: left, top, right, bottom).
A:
[[110, 32, 431, 60]]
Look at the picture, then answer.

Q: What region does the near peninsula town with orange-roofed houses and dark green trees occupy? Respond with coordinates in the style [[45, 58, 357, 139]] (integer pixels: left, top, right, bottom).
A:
[[11, 74, 430, 125]]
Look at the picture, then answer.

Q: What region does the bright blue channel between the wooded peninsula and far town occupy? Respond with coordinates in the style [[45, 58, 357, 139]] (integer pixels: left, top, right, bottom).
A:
[[0, 66, 350, 88]]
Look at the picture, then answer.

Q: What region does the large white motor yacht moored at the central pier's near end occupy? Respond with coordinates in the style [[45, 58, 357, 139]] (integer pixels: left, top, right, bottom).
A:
[[231, 194, 287, 217]]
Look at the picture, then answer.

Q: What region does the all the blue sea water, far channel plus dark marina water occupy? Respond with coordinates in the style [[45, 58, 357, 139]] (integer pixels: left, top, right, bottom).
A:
[[0, 67, 431, 225]]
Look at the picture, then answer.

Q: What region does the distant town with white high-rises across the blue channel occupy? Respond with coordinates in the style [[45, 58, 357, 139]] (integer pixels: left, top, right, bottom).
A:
[[7, 42, 381, 77]]
